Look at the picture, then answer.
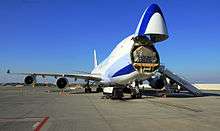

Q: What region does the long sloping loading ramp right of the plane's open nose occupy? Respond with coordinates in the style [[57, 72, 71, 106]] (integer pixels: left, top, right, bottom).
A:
[[158, 66, 202, 96]]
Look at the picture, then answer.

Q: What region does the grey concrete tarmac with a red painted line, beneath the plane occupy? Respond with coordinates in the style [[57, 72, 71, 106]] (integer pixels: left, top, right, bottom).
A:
[[0, 86, 220, 131]]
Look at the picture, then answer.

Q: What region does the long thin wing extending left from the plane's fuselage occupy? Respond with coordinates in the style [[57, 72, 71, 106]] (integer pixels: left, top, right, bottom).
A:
[[7, 70, 101, 81]]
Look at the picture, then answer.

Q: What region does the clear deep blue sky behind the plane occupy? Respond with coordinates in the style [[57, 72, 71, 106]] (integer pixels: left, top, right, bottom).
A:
[[0, 0, 220, 83]]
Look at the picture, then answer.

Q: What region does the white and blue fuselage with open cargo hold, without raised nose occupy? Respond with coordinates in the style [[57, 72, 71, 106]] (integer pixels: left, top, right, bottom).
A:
[[92, 35, 160, 84]]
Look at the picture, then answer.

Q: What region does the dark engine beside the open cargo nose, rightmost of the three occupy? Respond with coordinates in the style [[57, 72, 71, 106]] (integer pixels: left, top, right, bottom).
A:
[[148, 77, 165, 89]]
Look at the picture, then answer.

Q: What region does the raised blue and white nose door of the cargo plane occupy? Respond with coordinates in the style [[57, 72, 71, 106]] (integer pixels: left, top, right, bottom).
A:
[[135, 4, 168, 42]]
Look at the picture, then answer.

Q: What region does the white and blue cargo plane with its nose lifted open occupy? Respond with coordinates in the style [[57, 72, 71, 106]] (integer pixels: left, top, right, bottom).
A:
[[8, 4, 203, 98]]
